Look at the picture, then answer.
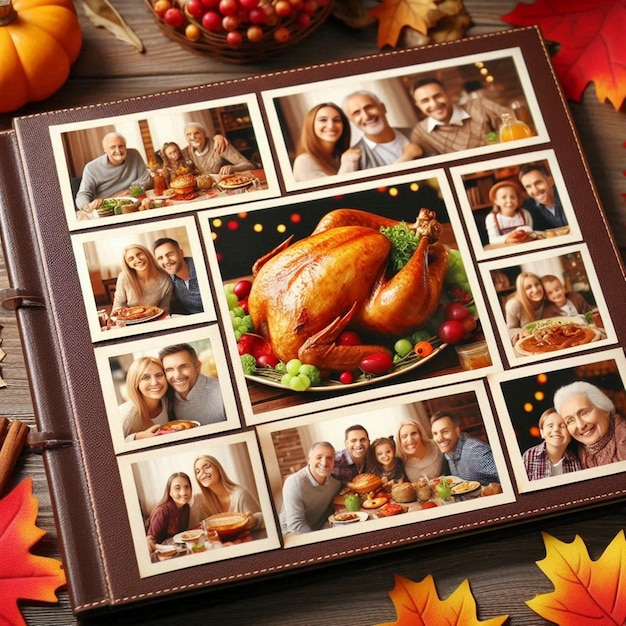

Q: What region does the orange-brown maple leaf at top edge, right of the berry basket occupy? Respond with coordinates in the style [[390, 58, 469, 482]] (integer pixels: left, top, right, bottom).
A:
[[368, 0, 441, 49]]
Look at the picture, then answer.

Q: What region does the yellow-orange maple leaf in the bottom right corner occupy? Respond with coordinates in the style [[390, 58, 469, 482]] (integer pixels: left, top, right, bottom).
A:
[[526, 530, 626, 626]]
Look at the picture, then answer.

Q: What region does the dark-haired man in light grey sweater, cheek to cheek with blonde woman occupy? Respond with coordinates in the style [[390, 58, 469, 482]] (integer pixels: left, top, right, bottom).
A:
[[159, 343, 226, 425]]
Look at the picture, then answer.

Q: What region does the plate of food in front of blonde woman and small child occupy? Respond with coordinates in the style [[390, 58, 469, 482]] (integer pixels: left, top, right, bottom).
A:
[[515, 317, 601, 356]]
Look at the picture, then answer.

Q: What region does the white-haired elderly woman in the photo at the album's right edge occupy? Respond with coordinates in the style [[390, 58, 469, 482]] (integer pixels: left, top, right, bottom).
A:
[[554, 381, 626, 467]]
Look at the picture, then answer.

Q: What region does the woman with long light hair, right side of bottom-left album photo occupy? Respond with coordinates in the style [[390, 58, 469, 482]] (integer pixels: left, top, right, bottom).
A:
[[191, 454, 263, 529]]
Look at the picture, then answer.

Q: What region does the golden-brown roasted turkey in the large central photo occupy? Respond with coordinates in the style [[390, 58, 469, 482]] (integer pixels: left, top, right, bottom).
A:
[[248, 209, 448, 371]]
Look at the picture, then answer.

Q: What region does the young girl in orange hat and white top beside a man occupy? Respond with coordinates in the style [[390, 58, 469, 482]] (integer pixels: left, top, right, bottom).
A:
[[485, 180, 533, 244]]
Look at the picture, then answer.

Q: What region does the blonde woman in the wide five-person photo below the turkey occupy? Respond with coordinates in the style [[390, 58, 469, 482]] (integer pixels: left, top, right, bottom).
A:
[[397, 419, 445, 483]]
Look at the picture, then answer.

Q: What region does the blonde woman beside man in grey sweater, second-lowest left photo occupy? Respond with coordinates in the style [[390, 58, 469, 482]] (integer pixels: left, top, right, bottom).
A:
[[119, 356, 169, 441]]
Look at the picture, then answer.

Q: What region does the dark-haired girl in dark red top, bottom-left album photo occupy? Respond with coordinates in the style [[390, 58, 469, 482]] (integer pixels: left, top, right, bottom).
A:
[[147, 472, 191, 552]]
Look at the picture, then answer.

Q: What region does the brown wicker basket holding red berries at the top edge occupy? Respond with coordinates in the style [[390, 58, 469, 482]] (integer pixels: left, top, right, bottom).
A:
[[144, 0, 333, 64]]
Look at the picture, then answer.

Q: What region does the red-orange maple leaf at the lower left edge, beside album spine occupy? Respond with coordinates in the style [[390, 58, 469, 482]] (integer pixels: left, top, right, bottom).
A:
[[0, 478, 65, 626]]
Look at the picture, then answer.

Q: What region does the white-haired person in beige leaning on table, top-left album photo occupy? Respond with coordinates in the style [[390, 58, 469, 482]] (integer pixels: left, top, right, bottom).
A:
[[183, 122, 254, 176]]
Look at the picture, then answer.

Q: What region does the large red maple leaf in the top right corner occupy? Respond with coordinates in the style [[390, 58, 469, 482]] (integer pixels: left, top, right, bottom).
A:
[[502, 0, 626, 111]]
